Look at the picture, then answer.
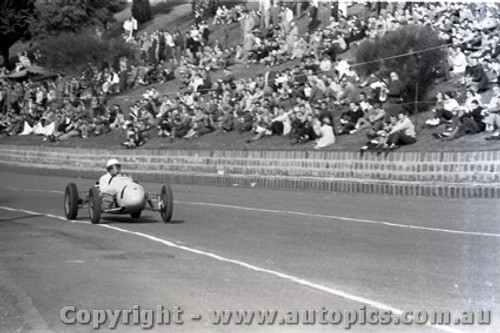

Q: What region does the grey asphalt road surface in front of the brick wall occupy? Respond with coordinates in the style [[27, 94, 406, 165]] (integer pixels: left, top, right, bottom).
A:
[[0, 172, 500, 332]]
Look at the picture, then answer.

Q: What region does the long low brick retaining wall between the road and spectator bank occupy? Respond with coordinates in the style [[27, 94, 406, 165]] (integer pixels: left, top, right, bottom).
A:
[[0, 145, 500, 198]]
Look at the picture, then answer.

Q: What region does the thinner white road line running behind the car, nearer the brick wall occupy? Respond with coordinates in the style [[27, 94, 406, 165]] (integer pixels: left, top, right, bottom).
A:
[[3, 187, 500, 238]]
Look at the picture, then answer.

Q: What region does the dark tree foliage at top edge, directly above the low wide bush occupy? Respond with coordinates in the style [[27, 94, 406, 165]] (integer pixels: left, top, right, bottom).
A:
[[31, 0, 122, 38]]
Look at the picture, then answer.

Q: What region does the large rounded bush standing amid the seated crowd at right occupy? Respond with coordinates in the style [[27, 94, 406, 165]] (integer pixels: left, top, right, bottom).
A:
[[355, 25, 445, 107]]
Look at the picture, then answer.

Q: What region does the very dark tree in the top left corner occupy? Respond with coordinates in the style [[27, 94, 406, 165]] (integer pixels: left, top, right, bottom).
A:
[[0, 0, 35, 67]]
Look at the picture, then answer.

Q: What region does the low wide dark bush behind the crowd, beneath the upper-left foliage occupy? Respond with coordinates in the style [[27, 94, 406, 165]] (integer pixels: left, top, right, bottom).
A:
[[40, 32, 135, 71]]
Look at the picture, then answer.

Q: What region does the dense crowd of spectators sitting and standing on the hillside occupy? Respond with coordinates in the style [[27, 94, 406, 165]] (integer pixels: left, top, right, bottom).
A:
[[0, 0, 500, 152]]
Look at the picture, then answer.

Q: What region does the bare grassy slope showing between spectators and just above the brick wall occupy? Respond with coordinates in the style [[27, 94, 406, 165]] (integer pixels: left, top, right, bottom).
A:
[[0, 3, 500, 151]]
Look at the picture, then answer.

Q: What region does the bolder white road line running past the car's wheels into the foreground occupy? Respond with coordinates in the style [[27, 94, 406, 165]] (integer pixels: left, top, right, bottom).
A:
[[0, 202, 462, 333]]
